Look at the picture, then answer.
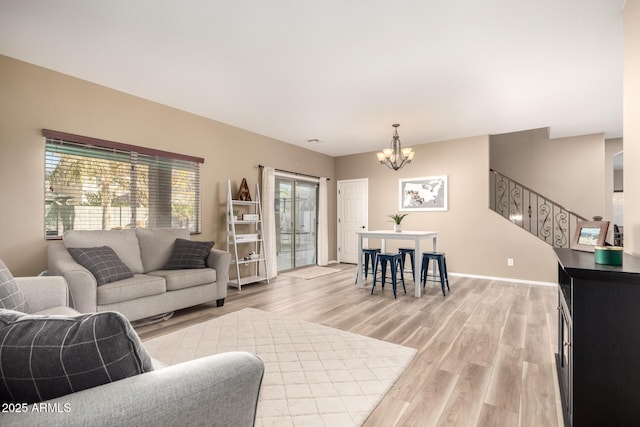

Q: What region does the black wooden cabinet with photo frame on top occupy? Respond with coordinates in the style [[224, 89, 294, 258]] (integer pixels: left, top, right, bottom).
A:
[[555, 249, 640, 426]]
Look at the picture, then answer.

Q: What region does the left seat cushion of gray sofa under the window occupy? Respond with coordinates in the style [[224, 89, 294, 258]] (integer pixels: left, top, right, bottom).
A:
[[97, 274, 167, 305]]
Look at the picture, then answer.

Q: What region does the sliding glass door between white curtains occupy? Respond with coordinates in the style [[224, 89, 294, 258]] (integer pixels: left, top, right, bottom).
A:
[[275, 176, 318, 271]]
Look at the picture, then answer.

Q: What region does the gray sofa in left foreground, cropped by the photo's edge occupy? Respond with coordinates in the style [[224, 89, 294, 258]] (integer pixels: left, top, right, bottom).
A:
[[0, 277, 264, 427]]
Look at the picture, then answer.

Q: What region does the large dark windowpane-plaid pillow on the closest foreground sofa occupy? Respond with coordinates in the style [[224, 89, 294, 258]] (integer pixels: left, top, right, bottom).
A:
[[0, 309, 153, 403]]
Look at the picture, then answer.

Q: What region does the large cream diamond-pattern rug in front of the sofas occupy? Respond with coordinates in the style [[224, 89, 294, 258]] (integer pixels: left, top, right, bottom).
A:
[[144, 308, 416, 427]]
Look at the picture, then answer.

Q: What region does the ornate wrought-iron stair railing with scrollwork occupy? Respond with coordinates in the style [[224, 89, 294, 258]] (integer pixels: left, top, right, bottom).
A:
[[489, 169, 586, 248]]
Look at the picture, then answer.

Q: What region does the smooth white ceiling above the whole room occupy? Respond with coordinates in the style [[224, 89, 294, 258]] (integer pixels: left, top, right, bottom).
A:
[[0, 0, 625, 156]]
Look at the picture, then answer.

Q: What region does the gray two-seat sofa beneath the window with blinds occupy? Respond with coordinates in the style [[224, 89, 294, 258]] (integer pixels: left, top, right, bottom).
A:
[[48, 228, 231, 321]]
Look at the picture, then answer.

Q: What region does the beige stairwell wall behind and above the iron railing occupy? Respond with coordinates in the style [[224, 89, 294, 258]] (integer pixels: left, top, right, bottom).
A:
[[490, 128, 612, 220]]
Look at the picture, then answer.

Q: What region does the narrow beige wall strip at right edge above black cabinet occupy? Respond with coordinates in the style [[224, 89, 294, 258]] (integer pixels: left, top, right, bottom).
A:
[[623, 0, 640, 254]]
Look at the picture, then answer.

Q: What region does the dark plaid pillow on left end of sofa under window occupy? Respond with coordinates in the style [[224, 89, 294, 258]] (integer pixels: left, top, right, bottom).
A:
[[67, 246, 133, 286]]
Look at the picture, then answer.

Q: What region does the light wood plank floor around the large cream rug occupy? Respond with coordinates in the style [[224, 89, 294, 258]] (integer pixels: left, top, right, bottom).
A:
[[136, 265, 563, 427]]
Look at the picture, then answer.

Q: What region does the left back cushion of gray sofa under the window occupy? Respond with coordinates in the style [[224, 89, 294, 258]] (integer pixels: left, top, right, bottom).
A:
[[62, 230, 142, 273]]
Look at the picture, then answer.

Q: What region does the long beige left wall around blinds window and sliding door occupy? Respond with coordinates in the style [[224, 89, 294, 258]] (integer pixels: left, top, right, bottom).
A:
[[0, 56, 337, 276]]
